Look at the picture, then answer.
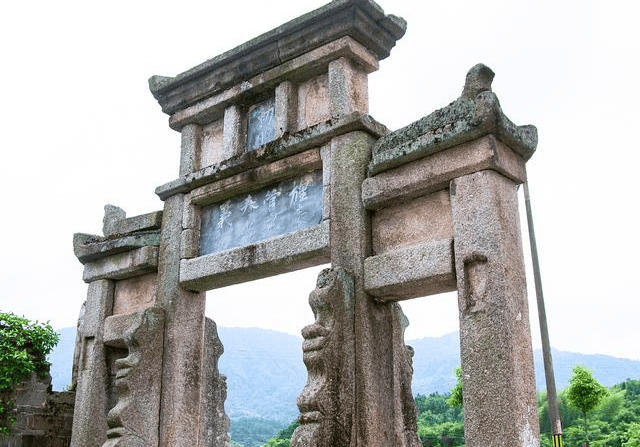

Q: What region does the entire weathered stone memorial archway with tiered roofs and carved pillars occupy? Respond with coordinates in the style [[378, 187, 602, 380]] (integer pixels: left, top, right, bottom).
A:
[[72, 0, 539, 447]]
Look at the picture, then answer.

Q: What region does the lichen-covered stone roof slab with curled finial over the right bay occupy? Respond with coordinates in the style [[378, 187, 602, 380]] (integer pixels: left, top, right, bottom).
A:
[[369, 64, 538, 175]]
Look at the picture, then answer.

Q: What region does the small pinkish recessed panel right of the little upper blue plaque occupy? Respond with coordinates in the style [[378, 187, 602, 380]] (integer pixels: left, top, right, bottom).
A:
[[296, 74, 331, 130]]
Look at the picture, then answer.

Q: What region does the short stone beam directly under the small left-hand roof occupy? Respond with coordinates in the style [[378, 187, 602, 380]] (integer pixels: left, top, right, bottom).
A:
[[82, 246, 158, 282]]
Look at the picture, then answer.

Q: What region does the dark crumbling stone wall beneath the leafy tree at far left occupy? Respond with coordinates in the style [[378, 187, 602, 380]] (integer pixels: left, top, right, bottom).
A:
[[0, 374, 75, 447]]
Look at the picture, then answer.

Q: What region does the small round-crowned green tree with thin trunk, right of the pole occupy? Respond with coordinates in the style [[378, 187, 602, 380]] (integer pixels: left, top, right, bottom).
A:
[[566, 365, 608, 444]]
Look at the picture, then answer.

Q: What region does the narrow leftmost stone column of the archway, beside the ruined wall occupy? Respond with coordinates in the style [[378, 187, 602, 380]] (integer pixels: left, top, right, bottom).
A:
[[71, 279, 114, 447]]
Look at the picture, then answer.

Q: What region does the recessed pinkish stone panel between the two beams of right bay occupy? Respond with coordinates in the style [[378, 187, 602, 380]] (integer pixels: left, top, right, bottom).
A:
[[371, 189, 453, 254]]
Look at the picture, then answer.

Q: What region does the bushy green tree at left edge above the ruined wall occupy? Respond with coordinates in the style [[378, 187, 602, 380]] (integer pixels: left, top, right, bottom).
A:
[[0, 312, 58, 435]]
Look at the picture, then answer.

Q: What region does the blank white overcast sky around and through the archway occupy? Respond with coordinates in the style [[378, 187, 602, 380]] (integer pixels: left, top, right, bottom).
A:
[[0, 0, 640, 359]]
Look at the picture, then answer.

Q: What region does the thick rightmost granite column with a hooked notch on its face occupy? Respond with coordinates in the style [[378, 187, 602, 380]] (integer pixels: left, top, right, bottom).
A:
[[450, 170, 539, 447]]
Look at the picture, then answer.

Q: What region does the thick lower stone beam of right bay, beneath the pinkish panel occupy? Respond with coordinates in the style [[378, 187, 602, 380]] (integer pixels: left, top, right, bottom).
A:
[[364, 239, 456, 301]]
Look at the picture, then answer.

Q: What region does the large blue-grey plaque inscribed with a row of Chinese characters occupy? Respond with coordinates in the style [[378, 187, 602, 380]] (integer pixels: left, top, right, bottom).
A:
[[200, 171, 322, 256]]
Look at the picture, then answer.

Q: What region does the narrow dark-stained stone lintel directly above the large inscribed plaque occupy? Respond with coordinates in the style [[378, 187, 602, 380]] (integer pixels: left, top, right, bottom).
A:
[[189, 148, 322, 206]]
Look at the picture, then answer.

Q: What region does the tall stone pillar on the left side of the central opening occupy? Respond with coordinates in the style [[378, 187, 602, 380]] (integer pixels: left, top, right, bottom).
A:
[[157, 194, 205, 447]]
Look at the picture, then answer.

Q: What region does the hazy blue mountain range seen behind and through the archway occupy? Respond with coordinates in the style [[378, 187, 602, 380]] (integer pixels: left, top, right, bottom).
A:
[[49, 327, 640, 446]]
